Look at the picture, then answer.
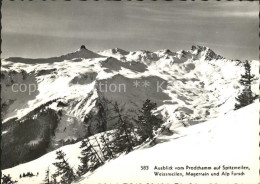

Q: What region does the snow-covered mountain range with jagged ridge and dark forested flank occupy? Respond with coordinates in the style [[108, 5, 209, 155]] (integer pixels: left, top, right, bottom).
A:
[[1, 46, 258, 172]]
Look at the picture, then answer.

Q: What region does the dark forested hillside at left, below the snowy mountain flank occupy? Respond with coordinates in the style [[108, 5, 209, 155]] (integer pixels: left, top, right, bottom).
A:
[[1, 107, 59, 169]]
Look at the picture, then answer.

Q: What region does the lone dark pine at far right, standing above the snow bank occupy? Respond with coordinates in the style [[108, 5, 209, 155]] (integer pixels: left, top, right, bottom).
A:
[[235, 60, 257, 109]]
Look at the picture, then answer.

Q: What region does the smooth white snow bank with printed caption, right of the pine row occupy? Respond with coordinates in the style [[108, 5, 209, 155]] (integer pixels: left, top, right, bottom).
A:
[[76, 103, 259, 184]]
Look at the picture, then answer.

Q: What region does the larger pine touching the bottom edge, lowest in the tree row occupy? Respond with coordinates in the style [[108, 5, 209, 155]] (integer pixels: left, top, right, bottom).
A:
[[53, 150, 76, 184]]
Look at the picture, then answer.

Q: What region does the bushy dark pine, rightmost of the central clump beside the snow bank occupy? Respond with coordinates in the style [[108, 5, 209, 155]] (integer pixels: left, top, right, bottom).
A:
[[136, 99, 163, 141]]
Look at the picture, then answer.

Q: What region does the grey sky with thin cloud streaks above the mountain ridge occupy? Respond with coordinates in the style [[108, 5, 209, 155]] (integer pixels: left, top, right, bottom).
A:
[[2, 0, 259, 60]]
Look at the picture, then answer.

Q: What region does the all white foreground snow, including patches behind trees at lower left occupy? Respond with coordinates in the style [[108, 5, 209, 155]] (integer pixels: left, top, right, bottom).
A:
[[3, 102, 259, 184]]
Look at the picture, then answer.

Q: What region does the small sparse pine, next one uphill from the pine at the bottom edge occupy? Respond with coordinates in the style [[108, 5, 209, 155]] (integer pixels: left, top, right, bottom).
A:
[[78, 138, 103, 175]]
